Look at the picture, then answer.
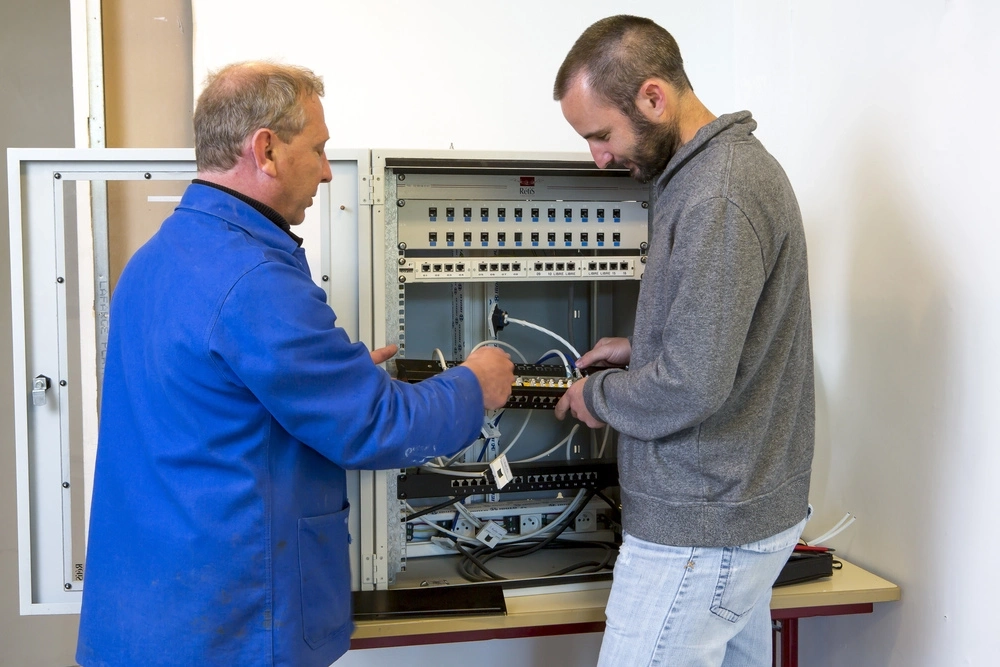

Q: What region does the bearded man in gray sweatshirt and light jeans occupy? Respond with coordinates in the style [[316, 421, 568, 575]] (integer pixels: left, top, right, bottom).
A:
[[554, 16, 815, 666]]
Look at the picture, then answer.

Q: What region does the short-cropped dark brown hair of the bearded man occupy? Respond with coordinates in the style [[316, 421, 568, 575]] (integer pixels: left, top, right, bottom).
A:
[[552, 14, 692, 117]]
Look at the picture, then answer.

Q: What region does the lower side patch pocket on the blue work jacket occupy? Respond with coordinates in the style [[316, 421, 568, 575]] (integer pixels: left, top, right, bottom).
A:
[[299, 508, 351, 649]]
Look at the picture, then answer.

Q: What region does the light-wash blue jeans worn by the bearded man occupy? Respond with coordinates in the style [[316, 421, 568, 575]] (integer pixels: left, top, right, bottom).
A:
[[598, 519, 806, 667]]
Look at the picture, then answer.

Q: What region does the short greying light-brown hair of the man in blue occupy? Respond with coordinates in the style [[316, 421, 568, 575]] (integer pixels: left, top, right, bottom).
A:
[[194, 62, 323, 171]]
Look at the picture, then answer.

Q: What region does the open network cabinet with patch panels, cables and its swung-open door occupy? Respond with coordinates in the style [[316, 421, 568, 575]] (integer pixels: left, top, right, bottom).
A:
[[8, 149, 648, 614]]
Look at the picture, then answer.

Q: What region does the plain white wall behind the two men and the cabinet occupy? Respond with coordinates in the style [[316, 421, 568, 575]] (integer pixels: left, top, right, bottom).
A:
[[194, 0, 1000, 667]]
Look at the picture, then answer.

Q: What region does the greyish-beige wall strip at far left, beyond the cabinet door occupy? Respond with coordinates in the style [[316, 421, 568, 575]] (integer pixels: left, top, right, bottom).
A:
[[0, 0, 77, 667]]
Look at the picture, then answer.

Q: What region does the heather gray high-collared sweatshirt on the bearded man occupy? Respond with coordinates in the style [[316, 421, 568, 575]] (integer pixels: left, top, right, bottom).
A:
[[584, 111, 815, 547]]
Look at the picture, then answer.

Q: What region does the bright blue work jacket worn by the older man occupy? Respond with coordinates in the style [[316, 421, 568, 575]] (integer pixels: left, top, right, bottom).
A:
[[77, 184, 483, 667]]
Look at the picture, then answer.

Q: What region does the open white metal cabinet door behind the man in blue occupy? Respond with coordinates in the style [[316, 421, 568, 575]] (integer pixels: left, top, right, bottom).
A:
[[8, 149, 371, 614]]
